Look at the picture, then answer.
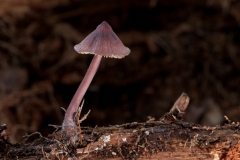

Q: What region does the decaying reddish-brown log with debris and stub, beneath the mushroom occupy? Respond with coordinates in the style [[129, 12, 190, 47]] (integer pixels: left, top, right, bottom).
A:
[[0, 94, 240, 160]]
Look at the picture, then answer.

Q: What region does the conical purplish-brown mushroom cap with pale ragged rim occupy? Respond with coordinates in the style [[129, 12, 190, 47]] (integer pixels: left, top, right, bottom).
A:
[[74, 21, 130, 58]]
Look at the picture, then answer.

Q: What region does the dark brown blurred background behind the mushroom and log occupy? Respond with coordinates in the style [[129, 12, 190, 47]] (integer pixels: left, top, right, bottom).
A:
[[0, 0, 240, 143]]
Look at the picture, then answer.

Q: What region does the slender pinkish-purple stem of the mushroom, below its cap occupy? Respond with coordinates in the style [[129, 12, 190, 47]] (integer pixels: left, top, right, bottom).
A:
[[62, 55, 102, 129]]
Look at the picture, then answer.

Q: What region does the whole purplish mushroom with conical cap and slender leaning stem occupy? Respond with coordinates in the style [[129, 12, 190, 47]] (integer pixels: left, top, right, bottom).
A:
[[62, 21, 130, 129]]
